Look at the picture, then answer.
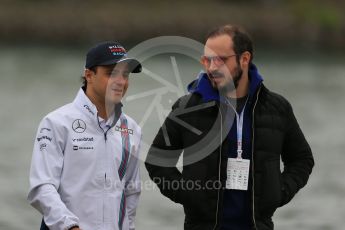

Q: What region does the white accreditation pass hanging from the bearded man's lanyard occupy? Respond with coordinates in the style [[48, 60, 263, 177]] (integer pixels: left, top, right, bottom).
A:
[[225, 158, 250, 190]]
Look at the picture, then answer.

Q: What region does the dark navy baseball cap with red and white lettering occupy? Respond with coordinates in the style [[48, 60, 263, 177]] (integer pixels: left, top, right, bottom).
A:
[[85, 42, 142, 73]]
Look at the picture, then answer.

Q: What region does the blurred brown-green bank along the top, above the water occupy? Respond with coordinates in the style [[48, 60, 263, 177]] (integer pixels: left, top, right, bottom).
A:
[[0, 0, 345, 49]]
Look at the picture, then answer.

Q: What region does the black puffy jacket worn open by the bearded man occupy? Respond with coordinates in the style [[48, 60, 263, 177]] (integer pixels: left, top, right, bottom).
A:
[[145, 84, 314, 230]]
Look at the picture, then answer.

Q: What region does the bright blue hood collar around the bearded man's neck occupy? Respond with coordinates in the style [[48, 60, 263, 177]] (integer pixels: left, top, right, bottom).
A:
[[188, 64, 263, 103]]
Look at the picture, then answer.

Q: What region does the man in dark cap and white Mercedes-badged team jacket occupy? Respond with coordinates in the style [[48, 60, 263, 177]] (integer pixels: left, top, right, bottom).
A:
[[28, 42, 142, 230]]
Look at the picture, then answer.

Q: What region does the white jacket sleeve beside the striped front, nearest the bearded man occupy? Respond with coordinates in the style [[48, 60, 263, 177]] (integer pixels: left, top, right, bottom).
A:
[[125, 136, 141, 230]]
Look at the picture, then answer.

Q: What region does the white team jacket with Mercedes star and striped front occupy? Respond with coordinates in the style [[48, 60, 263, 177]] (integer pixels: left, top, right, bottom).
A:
[[28, 89, 141, 230]]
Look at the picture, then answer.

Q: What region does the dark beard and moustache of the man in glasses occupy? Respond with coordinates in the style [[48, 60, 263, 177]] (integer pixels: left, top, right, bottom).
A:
[[208, 65, 243, 94]]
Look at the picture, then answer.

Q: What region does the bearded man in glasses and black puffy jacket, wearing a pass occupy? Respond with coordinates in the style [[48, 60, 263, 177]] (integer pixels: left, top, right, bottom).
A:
[[146, 25, 314, 230]]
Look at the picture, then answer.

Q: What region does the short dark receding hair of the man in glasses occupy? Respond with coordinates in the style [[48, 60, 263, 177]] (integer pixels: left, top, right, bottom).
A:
[[206, 25, 254, 62]]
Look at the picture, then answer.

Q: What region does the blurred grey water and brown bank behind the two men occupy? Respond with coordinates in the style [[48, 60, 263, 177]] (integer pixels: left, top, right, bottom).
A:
[[0, 0, 345, 230]]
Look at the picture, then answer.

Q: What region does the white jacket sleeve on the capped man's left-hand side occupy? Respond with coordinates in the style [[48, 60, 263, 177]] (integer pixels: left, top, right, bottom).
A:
[[28, 118, 79, 230]]
